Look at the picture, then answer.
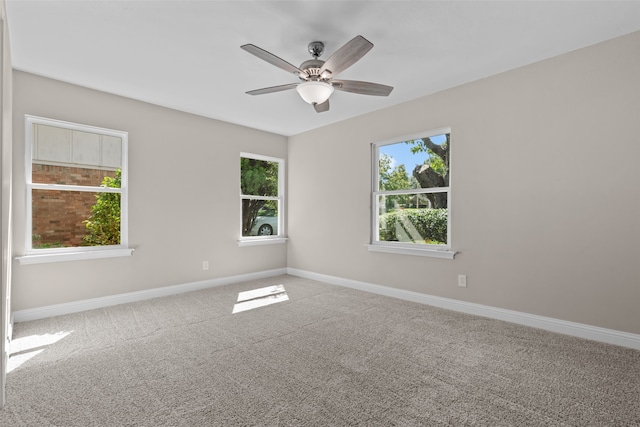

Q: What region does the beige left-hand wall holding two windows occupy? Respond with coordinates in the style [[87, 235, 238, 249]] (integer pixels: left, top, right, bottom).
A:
[[13, 71, 287, 310]]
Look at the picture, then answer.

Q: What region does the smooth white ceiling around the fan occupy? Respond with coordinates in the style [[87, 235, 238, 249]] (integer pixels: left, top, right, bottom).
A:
[[6, 0, 640, 135]]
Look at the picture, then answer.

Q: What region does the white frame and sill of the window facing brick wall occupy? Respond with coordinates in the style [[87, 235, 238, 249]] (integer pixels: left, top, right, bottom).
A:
[[16, 115, 133, 264]]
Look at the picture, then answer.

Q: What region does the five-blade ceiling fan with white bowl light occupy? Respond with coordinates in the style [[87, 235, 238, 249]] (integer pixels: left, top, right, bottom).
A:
[[240, 36, 393, 113]]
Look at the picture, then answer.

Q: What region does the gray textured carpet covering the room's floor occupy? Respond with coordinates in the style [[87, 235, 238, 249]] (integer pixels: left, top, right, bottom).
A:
[[0, 276, 640, 427]]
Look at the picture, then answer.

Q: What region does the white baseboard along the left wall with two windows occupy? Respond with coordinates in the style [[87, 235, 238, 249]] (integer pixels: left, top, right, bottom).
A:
[[12, 268, 287, 323]]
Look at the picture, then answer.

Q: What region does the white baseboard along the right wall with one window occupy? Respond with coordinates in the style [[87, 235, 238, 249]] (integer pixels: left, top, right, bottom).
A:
[[287, 268, 640, 350]]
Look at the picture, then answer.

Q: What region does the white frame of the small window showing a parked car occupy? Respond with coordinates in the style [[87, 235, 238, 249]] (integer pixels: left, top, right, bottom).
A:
[[238, 152, 287, 246]]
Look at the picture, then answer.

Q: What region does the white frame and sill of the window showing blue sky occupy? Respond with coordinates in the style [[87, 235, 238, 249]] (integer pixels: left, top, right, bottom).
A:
[[367, 128, 456, 259]]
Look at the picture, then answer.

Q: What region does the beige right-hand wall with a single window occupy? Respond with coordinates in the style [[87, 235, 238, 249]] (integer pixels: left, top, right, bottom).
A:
[[288, 33, 640, 334]]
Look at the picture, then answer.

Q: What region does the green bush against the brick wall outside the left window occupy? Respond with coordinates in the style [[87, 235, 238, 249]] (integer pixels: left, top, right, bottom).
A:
[[83, 169, 122, 246]]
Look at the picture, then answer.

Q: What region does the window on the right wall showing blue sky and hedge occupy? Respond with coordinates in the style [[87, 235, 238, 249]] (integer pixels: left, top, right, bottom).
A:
[[369, 129, 455, 258]]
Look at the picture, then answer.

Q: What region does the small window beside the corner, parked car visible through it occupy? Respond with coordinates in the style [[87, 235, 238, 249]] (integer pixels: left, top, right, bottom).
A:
[[240, 153, 285, 244]]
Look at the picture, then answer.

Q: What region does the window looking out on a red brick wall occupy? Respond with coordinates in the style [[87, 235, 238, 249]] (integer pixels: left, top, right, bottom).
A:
[[19, 116, 132, 263]]
